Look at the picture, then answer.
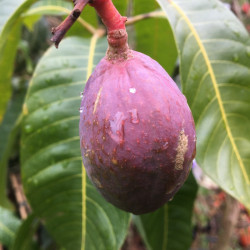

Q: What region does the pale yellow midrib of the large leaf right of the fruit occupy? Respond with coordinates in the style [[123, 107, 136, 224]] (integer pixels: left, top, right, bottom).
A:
[[169, 0, 250, 184]]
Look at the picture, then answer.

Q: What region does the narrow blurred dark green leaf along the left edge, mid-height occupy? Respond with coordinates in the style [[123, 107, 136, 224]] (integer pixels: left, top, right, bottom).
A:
[[0, 89, 25, 209]]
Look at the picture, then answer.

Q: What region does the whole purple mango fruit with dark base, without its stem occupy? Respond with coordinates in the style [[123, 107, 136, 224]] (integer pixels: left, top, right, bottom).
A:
[[79, 50, 196, 214]]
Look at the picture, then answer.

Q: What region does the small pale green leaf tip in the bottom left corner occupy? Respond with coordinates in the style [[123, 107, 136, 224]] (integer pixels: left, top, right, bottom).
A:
[[0, 207, 21, 247]]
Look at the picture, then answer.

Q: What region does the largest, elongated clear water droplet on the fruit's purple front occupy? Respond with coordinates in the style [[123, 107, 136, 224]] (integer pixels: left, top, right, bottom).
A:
[[110, 112, 125, 144]]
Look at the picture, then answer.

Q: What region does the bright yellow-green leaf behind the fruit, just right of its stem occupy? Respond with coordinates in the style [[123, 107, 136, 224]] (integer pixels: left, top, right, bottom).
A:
[[134, 0, 177, 75]]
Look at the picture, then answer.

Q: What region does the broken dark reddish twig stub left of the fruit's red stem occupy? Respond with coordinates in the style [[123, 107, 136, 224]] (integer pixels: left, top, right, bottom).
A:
[[51, 0, 89, 48]]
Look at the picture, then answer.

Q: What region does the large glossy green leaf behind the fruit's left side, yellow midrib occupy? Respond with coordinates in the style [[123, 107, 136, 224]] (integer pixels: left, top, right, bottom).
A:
[[21, 37, 129, 250]]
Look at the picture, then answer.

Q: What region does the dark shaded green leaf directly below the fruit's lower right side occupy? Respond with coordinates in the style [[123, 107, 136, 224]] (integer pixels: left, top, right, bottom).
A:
[[135, 174, 197, 250]]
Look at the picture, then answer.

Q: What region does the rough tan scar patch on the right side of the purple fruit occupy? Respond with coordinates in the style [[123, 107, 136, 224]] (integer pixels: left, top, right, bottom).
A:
[[175, 129, 188, 170]]
